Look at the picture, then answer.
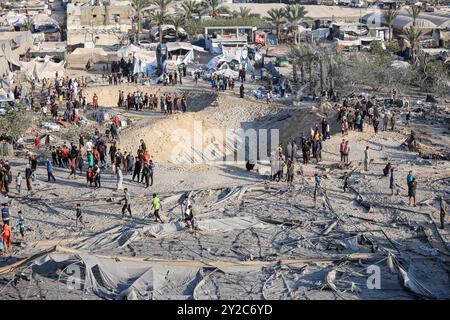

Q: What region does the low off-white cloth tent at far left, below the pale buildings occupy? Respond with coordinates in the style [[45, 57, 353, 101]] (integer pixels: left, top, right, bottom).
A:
[[20, 56, 65, 80]]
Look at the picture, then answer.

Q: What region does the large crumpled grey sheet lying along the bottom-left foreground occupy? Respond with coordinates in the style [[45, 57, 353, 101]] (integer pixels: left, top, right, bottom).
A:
[[35, 252, 202, 300]]
